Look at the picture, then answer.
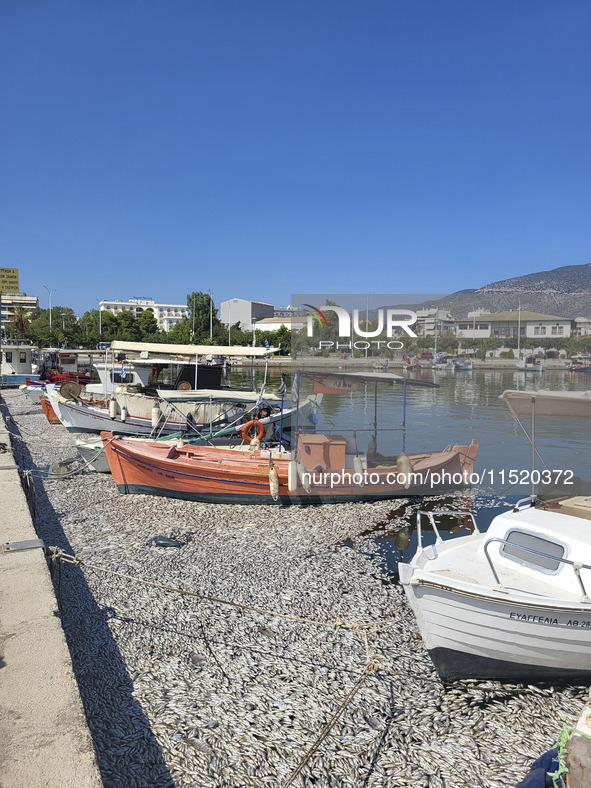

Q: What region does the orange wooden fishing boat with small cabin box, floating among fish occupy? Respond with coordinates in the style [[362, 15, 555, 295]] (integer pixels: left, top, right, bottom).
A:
[[101, 432, 478, 504]]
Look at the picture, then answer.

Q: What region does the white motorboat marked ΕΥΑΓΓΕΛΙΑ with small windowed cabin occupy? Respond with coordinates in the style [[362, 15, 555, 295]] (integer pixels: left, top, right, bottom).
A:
[[399, 499, 591, 682]]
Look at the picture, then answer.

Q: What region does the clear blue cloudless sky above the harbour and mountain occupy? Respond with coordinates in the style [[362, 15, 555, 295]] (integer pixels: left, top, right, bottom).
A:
[[0, 0, 591, 314]]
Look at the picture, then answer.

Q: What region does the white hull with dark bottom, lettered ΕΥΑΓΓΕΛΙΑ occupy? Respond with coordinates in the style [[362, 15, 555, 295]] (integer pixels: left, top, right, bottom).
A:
[[400, 576, 591, 682]]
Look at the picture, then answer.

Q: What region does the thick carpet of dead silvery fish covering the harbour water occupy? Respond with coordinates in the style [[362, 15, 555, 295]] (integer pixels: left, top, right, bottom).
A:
[[4, 391, 587, 788]]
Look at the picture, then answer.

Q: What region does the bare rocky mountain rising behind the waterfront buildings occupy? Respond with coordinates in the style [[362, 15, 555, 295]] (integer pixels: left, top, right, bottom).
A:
[[402, 263, 591, 318]]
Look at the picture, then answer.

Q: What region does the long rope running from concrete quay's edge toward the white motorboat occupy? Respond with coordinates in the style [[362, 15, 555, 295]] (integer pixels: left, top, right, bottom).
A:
[[47, 546, 396, 635]]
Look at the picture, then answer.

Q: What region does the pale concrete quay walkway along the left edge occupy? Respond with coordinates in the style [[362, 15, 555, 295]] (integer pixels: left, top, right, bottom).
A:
[[0, 406, 102, 788]]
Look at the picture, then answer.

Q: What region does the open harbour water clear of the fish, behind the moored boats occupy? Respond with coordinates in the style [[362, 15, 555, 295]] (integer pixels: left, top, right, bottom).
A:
[[229, 367, 591, 577]]
